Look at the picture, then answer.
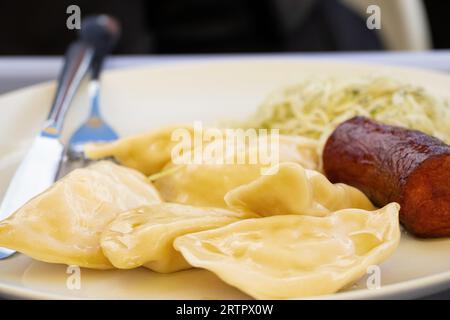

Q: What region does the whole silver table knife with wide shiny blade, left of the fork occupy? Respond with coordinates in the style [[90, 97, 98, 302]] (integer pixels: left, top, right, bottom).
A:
[[0, 41, 94, 259]]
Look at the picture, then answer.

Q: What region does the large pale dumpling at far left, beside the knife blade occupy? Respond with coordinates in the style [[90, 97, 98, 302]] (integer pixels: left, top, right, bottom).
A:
[[0, 161, 161, 269]]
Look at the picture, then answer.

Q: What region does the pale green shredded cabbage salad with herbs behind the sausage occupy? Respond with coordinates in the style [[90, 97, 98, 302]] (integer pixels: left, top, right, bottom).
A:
[[235, 77, 450, 153]]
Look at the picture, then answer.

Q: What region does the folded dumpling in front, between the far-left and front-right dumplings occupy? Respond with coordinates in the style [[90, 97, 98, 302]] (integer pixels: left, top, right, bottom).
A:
[[101, 203, 253, 273]]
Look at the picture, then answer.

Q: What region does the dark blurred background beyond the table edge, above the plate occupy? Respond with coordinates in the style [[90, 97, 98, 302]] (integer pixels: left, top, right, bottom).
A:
[[0, 0, 450, 55]]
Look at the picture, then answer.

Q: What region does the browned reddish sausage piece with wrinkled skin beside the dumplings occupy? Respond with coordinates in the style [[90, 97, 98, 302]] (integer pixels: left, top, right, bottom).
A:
[[323, 117, 450, 237]]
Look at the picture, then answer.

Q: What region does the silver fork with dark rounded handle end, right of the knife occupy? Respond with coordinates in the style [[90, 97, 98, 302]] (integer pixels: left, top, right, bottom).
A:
[[59, 15, 120, 177]]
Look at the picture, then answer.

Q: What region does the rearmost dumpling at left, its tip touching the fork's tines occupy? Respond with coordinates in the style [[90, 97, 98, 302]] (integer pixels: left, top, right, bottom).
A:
[[84, 125, 193, 176]]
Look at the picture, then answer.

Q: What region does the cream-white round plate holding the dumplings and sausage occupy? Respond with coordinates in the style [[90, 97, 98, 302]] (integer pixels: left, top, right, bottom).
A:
[[0, 58, 450, 299]]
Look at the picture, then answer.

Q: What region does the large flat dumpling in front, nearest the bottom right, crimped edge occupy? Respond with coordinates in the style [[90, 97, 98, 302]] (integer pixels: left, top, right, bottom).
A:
[[174, 203, 400, 299]]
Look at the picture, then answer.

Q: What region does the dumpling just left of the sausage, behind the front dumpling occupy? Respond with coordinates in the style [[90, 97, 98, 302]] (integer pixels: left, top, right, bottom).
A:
[[225, 162, 375, 216]]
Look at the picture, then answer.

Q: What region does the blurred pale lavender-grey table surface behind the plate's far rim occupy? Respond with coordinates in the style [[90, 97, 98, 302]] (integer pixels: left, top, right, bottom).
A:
[[0, 50, 450, 300]]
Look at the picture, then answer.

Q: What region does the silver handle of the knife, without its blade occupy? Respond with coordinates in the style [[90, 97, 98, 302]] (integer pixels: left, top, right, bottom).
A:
[[41, 41, 94, 137]]
